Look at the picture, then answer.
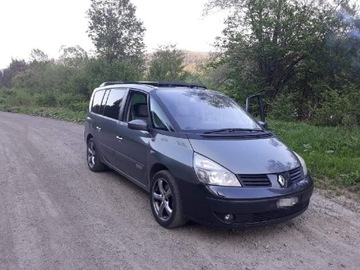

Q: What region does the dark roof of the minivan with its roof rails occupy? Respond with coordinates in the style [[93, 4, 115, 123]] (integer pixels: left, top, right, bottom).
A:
[[97, 81, 206, 92]]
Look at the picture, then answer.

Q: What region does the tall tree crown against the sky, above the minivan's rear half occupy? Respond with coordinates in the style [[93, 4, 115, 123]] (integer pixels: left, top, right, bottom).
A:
[[88, 0, 145, 61]]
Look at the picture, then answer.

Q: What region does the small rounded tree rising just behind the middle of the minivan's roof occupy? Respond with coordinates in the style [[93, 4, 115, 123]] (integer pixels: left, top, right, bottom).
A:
[[148, 45, 186, 81]]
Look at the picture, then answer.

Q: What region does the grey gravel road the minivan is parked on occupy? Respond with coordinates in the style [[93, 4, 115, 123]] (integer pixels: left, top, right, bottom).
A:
[[0, 112, 360, 270]]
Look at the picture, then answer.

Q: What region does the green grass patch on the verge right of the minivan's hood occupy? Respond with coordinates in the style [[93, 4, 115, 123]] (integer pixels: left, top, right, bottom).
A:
[[269, 121, 360, 195]]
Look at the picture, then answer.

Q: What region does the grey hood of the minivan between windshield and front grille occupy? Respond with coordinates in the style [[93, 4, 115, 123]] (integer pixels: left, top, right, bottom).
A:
[[189, 137, 300, 174]]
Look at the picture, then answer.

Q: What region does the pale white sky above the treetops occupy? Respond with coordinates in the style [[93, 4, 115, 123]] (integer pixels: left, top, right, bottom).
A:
[[0, 0, 224, 69]]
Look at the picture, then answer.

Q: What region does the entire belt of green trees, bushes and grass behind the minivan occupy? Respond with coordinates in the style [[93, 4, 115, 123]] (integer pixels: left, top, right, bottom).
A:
[[0, 0, 360, 194]]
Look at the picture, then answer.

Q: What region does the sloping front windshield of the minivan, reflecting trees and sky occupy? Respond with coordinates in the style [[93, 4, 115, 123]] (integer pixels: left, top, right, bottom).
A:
[[157, 89, 262, 132]]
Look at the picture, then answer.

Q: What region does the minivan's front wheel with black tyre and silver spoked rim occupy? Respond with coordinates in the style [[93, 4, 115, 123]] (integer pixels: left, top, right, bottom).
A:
[[150, 170, 187, 229]]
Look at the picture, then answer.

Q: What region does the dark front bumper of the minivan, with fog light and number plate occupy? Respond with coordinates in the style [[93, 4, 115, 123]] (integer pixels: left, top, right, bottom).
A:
[[184, 176, 313, 227]]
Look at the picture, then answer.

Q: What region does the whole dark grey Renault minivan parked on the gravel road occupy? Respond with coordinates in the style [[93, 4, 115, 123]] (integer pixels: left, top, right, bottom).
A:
[[84, 82, 313, 228]]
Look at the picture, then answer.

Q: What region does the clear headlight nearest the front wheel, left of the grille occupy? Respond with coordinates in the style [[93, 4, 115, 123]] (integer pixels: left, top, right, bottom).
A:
[[194, 153, 241, 187]]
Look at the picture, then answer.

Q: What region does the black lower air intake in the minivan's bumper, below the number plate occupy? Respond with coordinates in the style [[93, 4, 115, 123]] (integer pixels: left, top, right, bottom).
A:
[[234, 201, 309, 225]]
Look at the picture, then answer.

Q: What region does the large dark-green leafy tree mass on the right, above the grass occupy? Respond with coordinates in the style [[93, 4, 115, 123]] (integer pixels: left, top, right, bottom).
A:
[[208, 0, 360, 124]]
